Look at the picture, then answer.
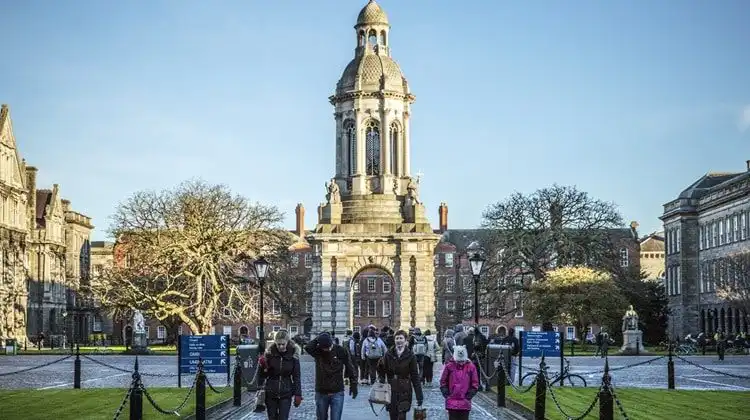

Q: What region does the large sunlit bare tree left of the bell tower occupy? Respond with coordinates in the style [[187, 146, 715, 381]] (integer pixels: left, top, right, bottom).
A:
[[92, 180, 291, 334]]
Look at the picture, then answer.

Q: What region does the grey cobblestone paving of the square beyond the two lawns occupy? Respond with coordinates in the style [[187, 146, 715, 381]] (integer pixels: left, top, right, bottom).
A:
[[0, 355, 750, 394]]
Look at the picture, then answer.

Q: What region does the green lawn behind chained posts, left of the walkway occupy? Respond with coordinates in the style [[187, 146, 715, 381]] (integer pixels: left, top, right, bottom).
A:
[[0, 388, 232, 420]]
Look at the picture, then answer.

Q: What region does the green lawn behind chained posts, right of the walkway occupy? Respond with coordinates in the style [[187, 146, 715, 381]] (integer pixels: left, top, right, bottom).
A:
[[506, 387, 750, 420]]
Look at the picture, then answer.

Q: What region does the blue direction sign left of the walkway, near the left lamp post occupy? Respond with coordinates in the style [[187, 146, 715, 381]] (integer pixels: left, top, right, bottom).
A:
[[179, 335, 230, 374]]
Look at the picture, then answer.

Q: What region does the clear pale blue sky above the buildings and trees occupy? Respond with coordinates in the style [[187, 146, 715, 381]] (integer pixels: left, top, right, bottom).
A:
[[0, 0, 750, 240]]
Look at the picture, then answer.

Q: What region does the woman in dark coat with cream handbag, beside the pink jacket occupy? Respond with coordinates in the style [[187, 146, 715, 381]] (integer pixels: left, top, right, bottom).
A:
[[378, 330, 424, 420]]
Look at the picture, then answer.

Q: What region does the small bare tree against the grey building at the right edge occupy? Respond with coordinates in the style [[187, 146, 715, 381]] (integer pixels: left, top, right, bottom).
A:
[[716, 252, 750, 314]]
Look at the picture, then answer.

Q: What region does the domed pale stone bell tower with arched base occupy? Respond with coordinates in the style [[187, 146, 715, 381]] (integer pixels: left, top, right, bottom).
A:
[[307, 0, 440, 331]]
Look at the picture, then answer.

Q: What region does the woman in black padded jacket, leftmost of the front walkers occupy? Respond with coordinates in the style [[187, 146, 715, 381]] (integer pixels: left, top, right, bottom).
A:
[[258, 330, 302, 420]]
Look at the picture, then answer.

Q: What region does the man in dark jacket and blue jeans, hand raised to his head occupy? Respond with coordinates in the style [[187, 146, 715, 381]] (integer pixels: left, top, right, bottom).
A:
[[305, 332, 358, 420]]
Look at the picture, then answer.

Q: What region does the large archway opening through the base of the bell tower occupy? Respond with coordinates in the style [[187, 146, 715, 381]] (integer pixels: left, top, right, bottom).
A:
[[351, 267, 398, 330]]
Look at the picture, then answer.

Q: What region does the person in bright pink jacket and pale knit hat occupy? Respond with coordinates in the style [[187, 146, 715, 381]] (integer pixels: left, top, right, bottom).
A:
[[440, 346, 479, 420]]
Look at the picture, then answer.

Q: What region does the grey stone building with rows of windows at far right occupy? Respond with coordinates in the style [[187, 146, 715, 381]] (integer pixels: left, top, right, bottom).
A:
[[661, 161, 750, 337]]
